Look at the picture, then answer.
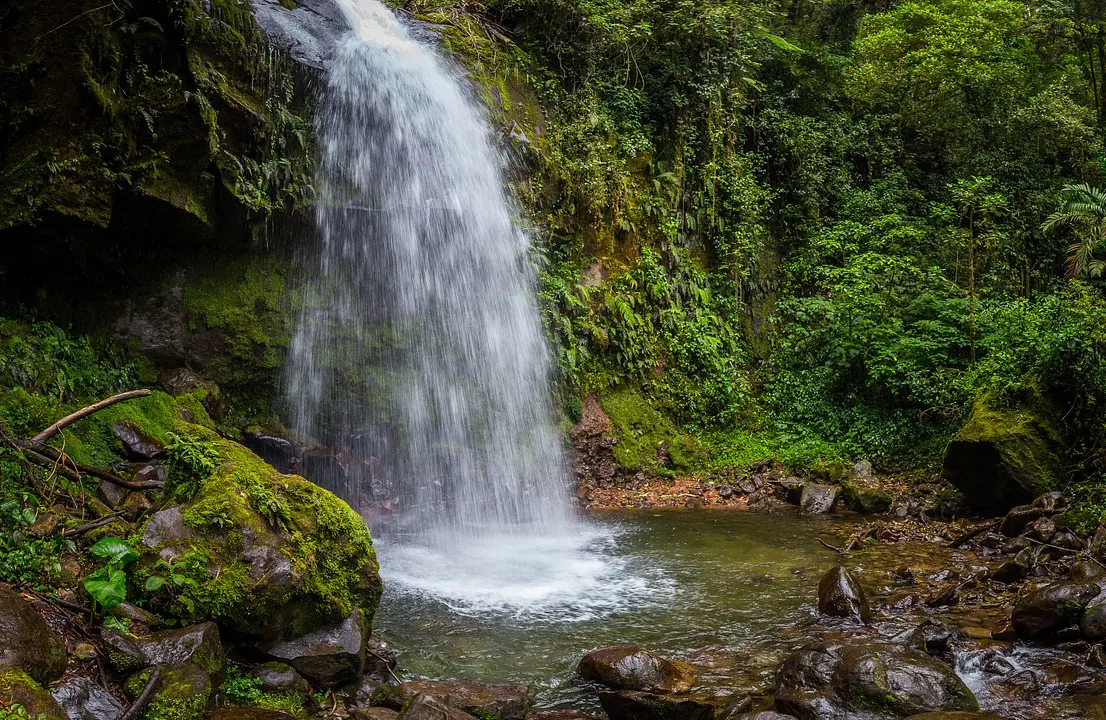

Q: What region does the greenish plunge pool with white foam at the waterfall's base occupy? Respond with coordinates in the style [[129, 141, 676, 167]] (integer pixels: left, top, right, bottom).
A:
[[376, 511, 836, 707]]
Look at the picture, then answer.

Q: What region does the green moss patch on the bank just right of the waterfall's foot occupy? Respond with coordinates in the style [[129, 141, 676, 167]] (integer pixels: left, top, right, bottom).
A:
[[599, 388, 708, 472]]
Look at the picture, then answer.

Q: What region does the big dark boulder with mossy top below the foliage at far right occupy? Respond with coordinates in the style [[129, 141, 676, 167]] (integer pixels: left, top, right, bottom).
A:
[[941, 390, 1063, 514]]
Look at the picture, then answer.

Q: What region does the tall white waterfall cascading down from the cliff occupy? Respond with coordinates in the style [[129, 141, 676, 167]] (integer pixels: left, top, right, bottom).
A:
[[286, 0, 574, 544]]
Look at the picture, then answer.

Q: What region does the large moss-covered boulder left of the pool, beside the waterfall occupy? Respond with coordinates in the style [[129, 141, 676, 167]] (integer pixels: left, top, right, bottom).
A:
[[133, 422, 382, 641]]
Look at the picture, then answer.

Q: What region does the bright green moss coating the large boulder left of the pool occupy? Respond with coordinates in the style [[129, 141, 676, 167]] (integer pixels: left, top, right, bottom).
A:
[[135, 422, 380, 636]]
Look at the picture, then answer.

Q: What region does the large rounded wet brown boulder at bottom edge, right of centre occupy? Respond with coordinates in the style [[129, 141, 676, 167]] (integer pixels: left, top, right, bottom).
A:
[[775, 641, 979, 720]]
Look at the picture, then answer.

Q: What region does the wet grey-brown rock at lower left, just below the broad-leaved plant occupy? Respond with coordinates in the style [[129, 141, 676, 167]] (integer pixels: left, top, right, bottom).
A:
[[101, 623, 227, 679]]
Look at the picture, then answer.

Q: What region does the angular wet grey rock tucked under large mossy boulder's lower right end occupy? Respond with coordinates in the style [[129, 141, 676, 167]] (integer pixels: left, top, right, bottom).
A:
[[265, 609, 367, 689]]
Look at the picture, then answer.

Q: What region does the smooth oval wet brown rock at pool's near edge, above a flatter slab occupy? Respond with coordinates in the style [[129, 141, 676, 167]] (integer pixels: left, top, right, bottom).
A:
[[576, 646, 695, 692]]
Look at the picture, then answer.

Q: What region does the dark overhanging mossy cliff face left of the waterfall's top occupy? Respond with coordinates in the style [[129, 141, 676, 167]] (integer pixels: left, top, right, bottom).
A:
[[0, 0, 322, 302]]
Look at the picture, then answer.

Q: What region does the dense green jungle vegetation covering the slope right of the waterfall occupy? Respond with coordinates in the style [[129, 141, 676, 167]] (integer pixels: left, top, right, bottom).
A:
[[433, 0, 1106, 478]]
